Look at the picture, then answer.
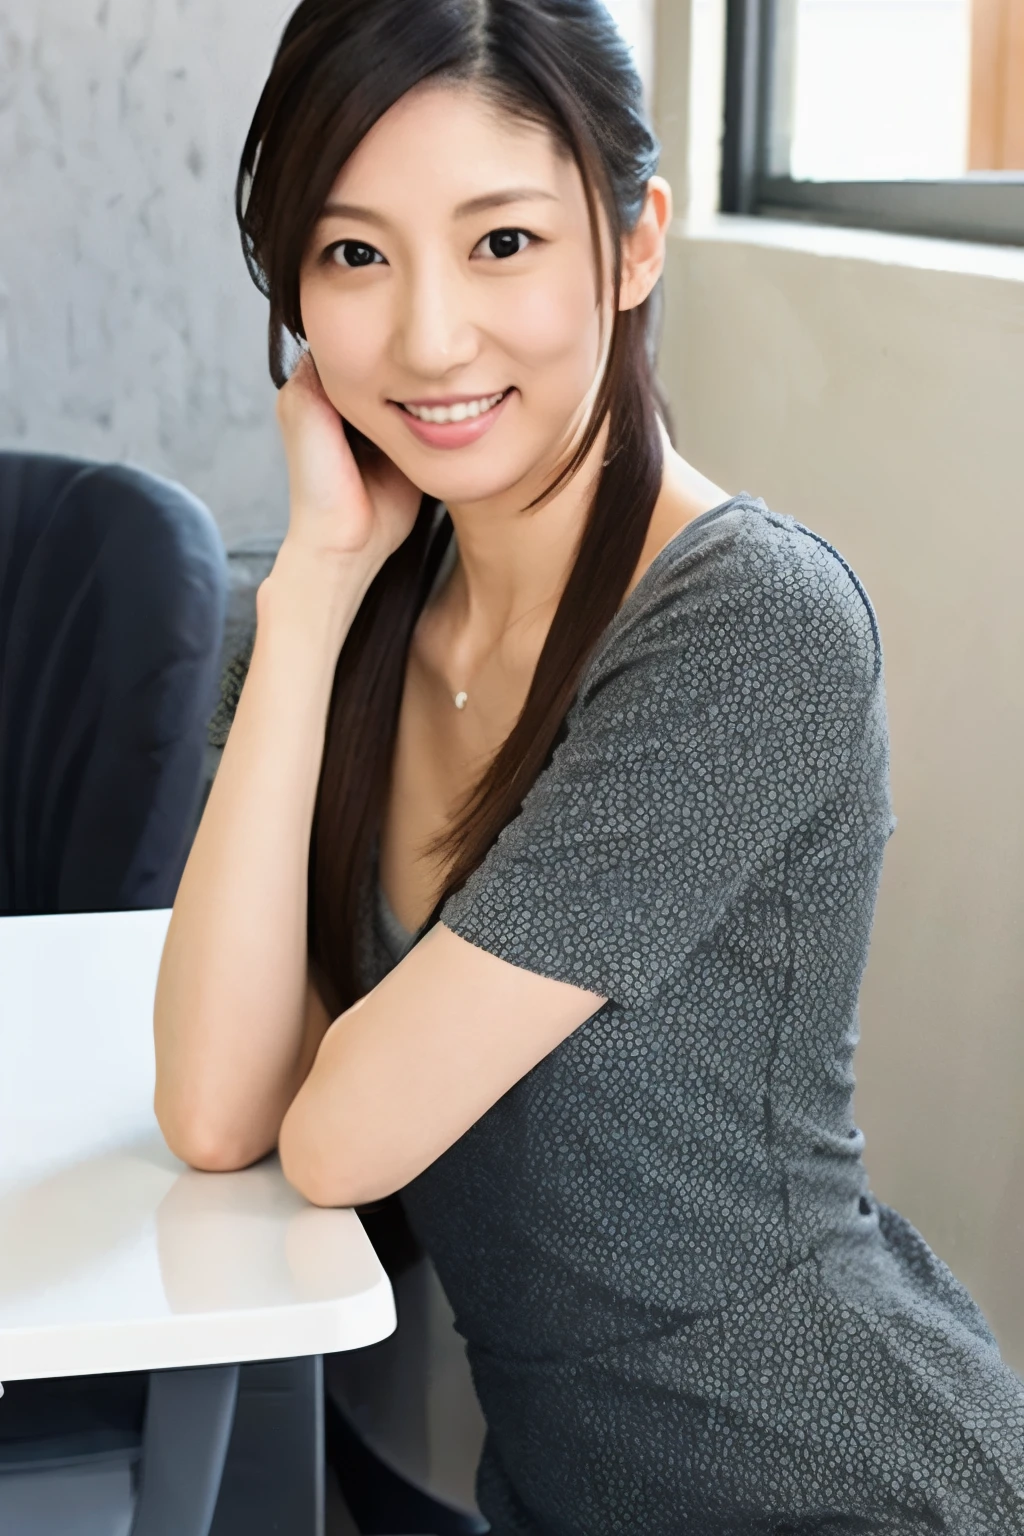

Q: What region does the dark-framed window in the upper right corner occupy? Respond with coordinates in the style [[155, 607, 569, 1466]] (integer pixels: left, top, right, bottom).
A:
[[722, 0, 1024, 244]]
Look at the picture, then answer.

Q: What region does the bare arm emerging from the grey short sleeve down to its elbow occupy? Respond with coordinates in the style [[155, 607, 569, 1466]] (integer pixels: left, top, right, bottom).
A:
[[281, 923, 605, 1206]]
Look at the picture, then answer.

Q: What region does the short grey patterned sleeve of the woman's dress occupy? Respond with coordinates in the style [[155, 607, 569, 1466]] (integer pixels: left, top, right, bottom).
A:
[[441, 507, 887, 1005]]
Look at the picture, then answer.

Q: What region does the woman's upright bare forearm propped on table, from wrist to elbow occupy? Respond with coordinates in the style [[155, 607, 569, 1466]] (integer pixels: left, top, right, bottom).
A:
[[155, 541, 372, 1166]]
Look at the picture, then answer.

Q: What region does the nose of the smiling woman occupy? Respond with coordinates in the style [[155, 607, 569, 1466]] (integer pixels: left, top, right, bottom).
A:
[[395, 257, 477, 379]]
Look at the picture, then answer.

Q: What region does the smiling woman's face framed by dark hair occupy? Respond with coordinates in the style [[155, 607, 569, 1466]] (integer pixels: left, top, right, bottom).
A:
[[301, 86, 611, 505]]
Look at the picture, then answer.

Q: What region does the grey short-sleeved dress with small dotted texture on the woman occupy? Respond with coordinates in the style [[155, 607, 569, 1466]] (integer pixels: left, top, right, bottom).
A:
[[365, 496, 1024, 1536]]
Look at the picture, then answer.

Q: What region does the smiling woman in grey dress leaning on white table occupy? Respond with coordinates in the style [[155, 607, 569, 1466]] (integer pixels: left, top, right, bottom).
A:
[[157, 0, 1024, 1536]]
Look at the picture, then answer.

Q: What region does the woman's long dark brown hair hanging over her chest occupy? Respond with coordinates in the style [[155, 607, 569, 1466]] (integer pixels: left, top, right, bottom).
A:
[[236, 0, 669, 1014]]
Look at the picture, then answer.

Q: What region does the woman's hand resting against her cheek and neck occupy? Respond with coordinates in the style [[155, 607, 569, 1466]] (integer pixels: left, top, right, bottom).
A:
[[278, 352, 422, 573]]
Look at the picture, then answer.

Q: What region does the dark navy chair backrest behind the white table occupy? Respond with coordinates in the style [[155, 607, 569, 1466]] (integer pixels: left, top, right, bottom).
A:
[[0, 453, 226, 915]]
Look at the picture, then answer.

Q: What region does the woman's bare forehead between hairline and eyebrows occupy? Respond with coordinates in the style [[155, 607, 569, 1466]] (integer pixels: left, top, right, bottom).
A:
[[323, 81, 583, 214]]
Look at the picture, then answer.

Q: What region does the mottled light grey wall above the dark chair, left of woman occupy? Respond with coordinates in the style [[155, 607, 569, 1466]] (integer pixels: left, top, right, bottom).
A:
[[0, 0, 292, 541]]
